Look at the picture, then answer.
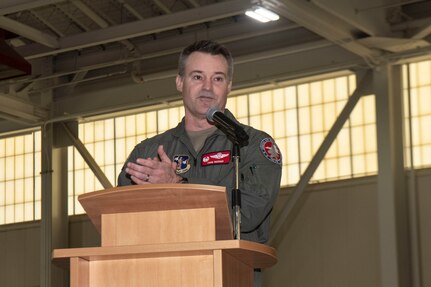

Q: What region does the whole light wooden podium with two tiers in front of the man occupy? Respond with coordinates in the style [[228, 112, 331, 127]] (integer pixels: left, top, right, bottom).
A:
[[53, 184, 277, 287]]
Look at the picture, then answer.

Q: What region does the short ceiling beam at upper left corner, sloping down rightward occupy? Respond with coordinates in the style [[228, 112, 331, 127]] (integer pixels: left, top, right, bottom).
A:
[[0, 16, 60, 49]]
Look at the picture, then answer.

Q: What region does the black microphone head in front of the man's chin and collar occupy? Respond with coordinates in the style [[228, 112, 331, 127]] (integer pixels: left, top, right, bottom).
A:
[[207, 107, 248, 147]]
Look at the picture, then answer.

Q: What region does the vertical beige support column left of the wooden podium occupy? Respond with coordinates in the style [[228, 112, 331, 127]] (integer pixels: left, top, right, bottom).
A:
[[39, 56, 69, 287]]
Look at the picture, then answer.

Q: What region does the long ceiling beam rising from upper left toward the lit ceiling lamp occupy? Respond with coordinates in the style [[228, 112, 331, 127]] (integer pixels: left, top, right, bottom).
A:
[[14, 0, 250, 59]]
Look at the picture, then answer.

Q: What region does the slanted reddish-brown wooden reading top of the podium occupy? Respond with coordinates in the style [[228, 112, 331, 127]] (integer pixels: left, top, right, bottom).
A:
[[78, 184, 233, 240]]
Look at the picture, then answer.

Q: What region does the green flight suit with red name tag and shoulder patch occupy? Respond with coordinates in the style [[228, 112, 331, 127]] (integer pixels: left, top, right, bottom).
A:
[[118, 110, 282, 243]]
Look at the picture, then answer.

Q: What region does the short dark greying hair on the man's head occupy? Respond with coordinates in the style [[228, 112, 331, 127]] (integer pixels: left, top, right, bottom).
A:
[[178, 40, 233, 80]]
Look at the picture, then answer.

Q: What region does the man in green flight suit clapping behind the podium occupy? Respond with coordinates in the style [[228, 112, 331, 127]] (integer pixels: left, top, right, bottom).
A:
[[118, 40, 281, 246]]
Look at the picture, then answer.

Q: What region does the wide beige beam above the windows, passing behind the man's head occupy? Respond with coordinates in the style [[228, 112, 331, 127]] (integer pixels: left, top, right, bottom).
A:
[[50, 44, 363, 121]]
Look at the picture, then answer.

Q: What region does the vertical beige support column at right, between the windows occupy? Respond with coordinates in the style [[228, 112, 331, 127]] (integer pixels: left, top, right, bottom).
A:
[[374, 65, 411, 287]]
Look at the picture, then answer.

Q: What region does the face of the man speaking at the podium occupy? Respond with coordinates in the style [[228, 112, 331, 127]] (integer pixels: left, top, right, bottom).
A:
[[176, 52, 232, 118]]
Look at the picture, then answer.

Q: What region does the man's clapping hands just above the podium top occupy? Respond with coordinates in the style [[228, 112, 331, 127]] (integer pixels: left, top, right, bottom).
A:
[[126, 145, 181, 184]]
